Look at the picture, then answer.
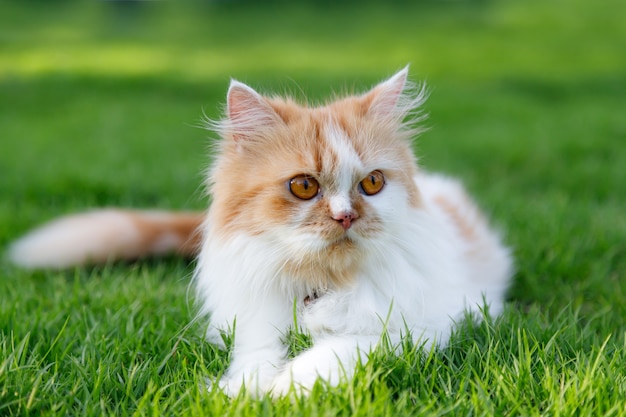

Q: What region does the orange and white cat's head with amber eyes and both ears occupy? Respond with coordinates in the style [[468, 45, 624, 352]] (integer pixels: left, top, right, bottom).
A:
[[209, 68, 425, 288]]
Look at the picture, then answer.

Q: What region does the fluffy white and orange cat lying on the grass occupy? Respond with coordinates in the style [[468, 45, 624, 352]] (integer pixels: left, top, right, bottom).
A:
[[11, 68, 512, 395]]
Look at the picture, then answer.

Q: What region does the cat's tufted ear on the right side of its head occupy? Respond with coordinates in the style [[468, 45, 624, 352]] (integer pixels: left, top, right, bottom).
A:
[[364, 65, 427, 119]]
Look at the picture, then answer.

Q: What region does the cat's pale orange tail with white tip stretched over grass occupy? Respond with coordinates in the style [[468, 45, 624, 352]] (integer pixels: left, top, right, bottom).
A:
[[8, 209, 205, 268]]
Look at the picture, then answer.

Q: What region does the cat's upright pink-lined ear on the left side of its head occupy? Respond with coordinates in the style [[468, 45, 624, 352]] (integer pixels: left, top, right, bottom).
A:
[[227, 80, 280, 141]]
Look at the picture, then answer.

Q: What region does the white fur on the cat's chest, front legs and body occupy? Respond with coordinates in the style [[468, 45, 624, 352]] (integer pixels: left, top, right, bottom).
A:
[[197, 174, 511, 395]]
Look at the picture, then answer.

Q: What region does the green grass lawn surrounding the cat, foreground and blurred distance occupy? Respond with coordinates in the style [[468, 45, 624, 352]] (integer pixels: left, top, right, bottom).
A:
[[0, 0, 626, 416]]
